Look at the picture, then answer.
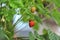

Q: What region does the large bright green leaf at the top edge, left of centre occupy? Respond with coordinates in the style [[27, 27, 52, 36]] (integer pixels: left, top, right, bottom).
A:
[[9, 0, 24, 8]]
